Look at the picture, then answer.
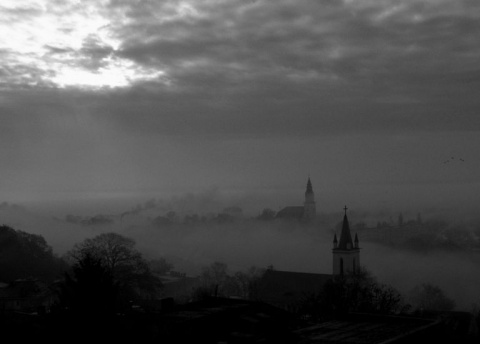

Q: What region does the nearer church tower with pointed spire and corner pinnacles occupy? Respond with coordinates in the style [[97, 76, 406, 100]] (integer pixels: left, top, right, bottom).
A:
[[332, 206, 360, 275]]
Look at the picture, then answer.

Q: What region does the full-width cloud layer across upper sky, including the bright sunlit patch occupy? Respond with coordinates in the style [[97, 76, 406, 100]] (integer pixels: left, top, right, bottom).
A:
[[0, 0, 480, 134]]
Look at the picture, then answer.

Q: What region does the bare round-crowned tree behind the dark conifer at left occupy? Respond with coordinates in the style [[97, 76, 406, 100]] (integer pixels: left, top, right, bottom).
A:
[[67, 233, 162, 300]]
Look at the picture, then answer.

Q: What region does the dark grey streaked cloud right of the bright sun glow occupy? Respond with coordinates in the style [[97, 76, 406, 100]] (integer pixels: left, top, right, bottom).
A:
[[100, 1, 480, 136]]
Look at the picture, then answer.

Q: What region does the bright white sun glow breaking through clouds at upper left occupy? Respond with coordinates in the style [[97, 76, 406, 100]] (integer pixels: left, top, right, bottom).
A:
[[0, 0, 167, 88]]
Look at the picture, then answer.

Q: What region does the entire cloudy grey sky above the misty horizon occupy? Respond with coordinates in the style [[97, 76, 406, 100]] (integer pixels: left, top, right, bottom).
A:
[[0, 0, 480, 212]]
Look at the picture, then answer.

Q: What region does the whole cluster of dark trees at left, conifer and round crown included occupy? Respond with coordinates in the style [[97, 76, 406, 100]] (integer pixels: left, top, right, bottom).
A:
[[0, 226, 172, 312]]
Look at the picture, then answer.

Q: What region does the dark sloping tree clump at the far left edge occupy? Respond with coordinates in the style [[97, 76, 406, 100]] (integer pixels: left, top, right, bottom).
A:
[[0, 225, 67, 282]]
